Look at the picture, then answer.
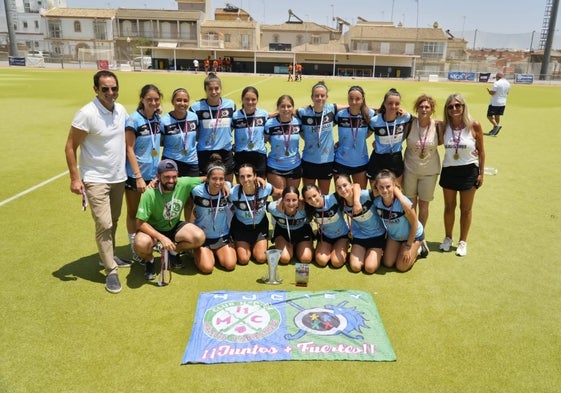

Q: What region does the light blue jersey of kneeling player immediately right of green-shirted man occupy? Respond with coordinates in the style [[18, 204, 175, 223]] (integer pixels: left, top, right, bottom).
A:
[[191, 182, 232, 239]]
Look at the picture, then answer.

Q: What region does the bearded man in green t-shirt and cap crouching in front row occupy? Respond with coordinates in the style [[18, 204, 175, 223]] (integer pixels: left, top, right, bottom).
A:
[[134, 160, 205, 280]]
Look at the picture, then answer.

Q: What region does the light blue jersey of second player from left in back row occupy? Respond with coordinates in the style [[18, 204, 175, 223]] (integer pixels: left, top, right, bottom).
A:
[[160, 112, 199, 165]]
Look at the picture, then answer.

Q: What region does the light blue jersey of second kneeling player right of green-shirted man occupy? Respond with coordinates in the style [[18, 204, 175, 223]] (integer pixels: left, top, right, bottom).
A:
[[228, 183, 273, 225]]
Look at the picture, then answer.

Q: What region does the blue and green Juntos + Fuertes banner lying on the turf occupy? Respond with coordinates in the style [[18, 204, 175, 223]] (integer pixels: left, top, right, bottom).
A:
[[181, 290, 396, 364]]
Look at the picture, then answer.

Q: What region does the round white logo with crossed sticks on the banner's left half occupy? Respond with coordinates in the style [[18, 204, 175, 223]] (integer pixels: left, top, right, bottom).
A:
[[203, 300, 281, 343]]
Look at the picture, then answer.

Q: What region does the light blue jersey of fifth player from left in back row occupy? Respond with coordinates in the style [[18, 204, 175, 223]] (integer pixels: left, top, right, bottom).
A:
[[265, 116, 302, 171]]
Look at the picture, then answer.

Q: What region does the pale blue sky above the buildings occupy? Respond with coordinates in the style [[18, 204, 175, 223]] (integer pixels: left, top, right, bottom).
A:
[[67, 0, 548, 34]]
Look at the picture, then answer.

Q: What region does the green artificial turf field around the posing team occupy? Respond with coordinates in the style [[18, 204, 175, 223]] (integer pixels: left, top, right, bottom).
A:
[[0, 68, 561, 393]]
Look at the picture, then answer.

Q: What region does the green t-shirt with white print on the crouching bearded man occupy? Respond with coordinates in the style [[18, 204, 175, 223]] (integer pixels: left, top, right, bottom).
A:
[[136, 177, 201, 232]]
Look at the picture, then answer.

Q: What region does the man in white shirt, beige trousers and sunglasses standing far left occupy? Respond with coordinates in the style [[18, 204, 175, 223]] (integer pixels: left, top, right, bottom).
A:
[[65, 70, 130, 293]]
